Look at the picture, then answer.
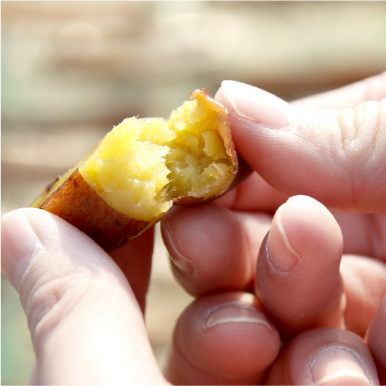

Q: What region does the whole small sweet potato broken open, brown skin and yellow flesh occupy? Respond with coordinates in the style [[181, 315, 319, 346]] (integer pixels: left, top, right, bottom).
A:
[[32, 89, 238, 252]]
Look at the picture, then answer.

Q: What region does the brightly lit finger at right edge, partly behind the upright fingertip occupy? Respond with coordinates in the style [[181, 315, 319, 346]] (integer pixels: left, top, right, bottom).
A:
[[340, 255, 386, 337]]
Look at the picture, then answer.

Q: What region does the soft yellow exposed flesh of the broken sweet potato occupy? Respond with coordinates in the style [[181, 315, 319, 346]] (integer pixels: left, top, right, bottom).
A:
[[79, 100, 231, 221]]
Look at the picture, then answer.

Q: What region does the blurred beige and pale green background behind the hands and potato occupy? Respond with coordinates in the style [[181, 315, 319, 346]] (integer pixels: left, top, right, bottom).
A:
[[0, 0, 386, 386]]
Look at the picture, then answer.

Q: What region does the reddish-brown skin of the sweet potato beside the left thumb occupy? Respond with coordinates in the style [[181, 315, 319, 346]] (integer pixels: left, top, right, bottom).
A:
[[39, 169, 151, 253]]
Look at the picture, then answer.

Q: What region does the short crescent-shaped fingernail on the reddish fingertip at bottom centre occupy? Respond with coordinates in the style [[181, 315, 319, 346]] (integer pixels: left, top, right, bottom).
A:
[[206, 303, 272, 330]]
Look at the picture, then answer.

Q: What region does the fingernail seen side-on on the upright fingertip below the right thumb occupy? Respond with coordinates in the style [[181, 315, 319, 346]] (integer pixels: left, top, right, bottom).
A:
[[268, 206, 300, 272]]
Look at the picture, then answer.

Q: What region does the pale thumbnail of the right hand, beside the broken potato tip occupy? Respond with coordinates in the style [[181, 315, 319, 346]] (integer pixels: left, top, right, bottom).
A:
[[221, 80, 294, 129]]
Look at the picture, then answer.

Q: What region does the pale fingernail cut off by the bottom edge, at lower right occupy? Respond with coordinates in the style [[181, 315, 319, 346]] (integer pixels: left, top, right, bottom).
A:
[[312, 348, 370, 386]]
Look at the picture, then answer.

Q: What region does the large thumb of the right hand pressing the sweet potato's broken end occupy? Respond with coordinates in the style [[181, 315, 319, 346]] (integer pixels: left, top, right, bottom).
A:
[[216, 81, 386, 212]]
